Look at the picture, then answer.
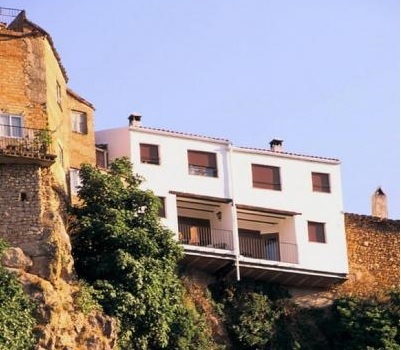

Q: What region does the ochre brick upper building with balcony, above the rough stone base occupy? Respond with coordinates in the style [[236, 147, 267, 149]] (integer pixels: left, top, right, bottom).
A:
[[0, 8, 95, 191]]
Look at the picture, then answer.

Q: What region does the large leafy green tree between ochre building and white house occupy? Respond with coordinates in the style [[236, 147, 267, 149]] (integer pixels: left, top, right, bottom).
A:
[[71, 158, 212, 350]]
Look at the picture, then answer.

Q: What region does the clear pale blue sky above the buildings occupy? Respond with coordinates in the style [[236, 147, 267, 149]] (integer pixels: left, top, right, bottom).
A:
[[4, 0, 400, 219]]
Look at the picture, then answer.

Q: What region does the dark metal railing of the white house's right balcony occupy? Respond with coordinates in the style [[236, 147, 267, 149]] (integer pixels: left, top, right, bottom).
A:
[[239, 235, 298, 264]]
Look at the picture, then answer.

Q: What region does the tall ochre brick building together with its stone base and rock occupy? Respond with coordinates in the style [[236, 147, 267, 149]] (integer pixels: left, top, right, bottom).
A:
[[0, 8, 115, 349]]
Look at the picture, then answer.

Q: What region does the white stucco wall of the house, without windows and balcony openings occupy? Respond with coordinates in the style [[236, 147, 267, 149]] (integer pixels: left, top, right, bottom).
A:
[[96, 127, 348, 273]]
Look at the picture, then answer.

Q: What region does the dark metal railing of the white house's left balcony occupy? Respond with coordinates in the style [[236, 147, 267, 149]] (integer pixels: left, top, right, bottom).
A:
[[178, 223, 234, 250]]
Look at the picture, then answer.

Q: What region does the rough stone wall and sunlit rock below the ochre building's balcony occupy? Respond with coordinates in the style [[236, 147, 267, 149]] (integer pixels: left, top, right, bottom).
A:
[[0, 164, 117, 350]]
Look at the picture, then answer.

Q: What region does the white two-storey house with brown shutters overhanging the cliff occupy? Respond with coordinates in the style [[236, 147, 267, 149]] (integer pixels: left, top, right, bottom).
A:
[[96, 115, 348, 287]]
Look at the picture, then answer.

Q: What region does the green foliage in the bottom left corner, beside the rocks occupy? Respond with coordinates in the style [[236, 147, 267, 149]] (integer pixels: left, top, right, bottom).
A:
[[0, 240, 36, 350]]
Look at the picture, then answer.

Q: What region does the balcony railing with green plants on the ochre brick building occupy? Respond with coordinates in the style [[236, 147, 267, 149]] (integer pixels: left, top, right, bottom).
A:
[[0, 124, 55, 160]]
